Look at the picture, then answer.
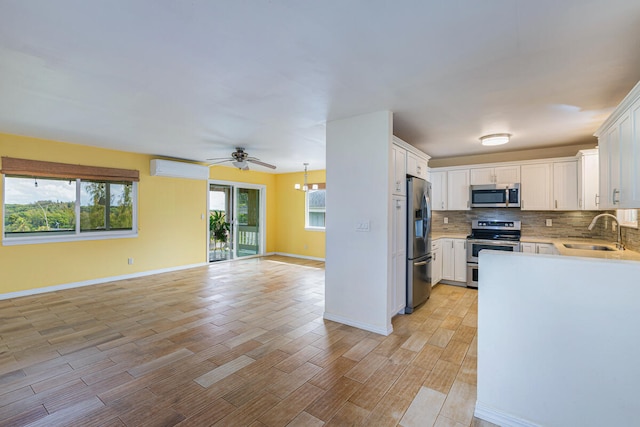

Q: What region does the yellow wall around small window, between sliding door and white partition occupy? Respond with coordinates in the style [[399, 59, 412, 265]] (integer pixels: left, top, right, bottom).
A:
[[276, 170, 330, 258]]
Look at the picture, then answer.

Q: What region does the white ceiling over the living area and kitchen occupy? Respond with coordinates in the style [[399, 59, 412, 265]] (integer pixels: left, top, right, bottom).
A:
[[0, 0, 640, 172]]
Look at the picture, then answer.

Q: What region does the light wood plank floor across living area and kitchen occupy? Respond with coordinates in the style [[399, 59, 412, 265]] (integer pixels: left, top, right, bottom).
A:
[[0, 257, 488, 426]]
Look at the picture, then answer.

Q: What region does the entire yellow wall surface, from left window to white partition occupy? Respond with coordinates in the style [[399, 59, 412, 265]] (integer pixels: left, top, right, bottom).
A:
[[0, 133, 325, 294]]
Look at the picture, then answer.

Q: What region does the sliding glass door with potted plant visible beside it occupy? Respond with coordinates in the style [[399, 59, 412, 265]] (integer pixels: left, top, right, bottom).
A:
[[208, 181, 266, 262]]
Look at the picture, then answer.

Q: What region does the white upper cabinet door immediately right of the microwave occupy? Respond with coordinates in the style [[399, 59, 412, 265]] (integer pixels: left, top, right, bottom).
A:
[[520, 163, 551, 211]]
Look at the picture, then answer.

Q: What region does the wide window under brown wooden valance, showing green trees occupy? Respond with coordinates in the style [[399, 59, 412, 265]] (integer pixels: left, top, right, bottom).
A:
[[3, 175, 137, 244]]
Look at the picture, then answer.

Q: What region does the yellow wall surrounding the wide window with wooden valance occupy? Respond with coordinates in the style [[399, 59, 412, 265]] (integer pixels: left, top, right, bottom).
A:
[[0, 134, 208, 294]]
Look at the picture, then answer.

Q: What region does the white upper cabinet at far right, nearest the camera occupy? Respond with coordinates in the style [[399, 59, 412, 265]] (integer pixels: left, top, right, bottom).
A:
[[595, 83, 640, 209]]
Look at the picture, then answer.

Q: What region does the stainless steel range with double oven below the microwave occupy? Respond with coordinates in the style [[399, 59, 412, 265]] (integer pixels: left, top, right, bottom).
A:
[[467, 219, 521, 288]]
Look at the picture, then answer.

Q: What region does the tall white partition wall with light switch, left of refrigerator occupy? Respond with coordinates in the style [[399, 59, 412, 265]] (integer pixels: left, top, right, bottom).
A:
[[324, 111, 393, 334]]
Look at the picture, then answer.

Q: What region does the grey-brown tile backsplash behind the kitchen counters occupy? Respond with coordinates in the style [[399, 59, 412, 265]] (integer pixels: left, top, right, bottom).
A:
[[432, 208, 640, 251]]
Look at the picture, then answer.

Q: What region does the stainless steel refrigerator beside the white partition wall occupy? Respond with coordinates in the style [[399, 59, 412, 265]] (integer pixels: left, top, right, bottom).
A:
[[404, 178, 432, 313]]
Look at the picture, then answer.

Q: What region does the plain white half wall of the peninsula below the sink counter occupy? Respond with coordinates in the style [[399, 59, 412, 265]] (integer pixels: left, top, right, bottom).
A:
[[476, 251, 640, 426]]
